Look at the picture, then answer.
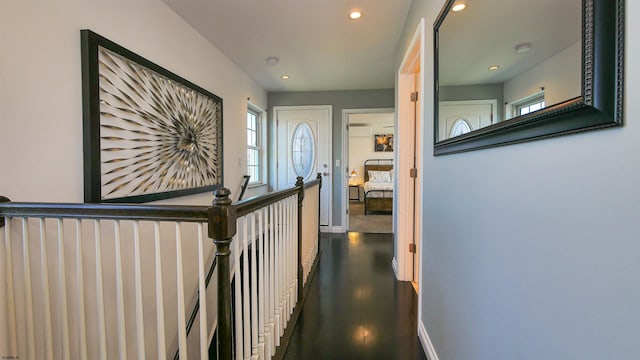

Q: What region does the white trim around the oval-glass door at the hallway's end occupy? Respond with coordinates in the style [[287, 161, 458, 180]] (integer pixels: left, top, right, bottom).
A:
[[271, 105, 334, 232]]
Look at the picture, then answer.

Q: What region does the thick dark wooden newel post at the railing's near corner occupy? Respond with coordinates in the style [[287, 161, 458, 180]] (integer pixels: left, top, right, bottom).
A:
[[209, 188, 236, 360]]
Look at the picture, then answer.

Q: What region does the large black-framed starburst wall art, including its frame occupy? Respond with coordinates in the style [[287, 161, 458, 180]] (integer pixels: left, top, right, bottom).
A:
[[81, 30, 223, 203]]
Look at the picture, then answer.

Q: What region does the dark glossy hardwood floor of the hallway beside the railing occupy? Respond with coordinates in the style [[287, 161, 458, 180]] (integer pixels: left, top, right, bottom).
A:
[[284, 232, 426, 359]]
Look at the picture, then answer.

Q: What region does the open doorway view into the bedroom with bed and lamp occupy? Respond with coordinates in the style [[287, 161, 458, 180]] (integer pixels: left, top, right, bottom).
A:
[[343, 109, 395, 233]]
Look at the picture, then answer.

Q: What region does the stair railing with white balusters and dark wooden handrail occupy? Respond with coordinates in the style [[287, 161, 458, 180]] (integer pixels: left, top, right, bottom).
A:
[[0, 174, 320, 359]]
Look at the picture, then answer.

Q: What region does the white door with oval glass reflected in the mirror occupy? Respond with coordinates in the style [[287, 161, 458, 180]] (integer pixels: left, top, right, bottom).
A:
[[438, 100, 497, 140]]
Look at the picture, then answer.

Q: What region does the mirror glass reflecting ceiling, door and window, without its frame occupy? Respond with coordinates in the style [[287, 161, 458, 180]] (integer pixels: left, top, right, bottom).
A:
[[436, 0, 582, 141]]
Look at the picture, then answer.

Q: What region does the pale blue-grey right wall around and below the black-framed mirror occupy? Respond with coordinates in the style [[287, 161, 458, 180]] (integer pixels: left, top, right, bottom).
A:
[[396, 0, 640, 360]]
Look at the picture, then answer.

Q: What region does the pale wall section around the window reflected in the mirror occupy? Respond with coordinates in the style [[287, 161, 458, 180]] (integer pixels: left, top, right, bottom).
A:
[[504, 41, 582, 113]]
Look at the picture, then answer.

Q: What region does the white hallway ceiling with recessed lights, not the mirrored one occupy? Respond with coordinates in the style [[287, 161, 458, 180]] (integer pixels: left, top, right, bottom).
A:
[[163, 0, 412, 91]]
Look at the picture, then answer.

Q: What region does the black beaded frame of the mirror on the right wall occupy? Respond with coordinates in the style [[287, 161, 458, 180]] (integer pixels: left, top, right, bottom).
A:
[[433, 0, 624, 156]]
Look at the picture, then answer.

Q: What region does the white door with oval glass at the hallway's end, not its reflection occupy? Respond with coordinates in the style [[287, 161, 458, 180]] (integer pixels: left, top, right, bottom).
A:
[[273, 105, 332, 231]]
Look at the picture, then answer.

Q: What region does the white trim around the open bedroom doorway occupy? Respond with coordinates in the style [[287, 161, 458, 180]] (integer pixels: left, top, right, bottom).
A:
[[340, 108, 397, 232]]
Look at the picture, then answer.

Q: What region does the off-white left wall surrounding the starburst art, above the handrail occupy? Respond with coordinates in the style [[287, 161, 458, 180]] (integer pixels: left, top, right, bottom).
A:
[[0, 0, 267, 204]]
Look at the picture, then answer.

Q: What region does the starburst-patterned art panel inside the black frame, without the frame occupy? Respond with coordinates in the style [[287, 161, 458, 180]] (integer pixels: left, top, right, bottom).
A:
[[98, 47, 222, 199]]
